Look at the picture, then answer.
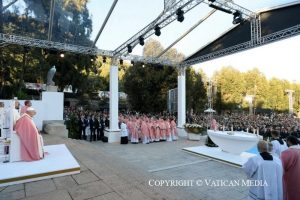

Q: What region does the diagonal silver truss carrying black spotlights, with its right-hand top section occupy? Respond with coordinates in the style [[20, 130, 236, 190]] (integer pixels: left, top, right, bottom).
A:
[[114, 0, 256, 56]]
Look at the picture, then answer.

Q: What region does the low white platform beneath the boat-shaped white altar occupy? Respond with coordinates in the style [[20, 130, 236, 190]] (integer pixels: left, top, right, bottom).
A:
[[182, 146, 256, 167]]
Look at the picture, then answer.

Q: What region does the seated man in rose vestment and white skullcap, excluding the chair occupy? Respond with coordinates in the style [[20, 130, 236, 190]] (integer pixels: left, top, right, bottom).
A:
[[15, 107, 44, 161]]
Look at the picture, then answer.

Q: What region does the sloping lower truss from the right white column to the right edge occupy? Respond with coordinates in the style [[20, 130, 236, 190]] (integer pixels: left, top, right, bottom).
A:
[[181, 24, 300, 67]]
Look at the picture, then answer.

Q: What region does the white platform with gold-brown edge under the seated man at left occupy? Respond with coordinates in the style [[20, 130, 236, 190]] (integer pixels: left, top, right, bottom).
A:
[[0, 144, 80, 187]]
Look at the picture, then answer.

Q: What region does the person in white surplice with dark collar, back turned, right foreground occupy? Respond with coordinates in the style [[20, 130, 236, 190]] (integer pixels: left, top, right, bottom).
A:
[[243, 140, 283, 200]]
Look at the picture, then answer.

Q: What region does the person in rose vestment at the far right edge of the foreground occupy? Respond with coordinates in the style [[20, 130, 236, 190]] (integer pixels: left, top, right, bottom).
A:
[[281, 136, 300, 200]]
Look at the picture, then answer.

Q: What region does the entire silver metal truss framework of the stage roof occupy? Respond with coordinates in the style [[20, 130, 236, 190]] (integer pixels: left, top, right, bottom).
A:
[[0, 0, 300, 69]]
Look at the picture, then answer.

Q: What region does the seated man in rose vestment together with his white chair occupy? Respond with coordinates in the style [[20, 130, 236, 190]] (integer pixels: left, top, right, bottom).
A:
[[10, 107, 44, 162]]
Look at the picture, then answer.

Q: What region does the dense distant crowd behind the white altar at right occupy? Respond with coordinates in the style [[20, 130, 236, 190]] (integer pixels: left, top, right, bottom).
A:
[[187, 113, 300, 138]]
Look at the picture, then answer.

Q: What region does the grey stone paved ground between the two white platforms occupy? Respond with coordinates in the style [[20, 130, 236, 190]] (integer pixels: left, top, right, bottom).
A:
[[0, 135, 248, 200]]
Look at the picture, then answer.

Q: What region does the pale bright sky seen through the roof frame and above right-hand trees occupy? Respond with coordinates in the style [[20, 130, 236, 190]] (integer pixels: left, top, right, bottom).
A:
[[88, 0, 300, 83]]
